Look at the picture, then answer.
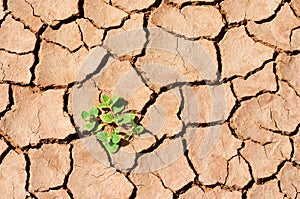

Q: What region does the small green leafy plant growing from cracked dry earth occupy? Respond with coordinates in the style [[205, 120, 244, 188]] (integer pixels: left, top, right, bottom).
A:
[[81, 94, 144, 153]]
